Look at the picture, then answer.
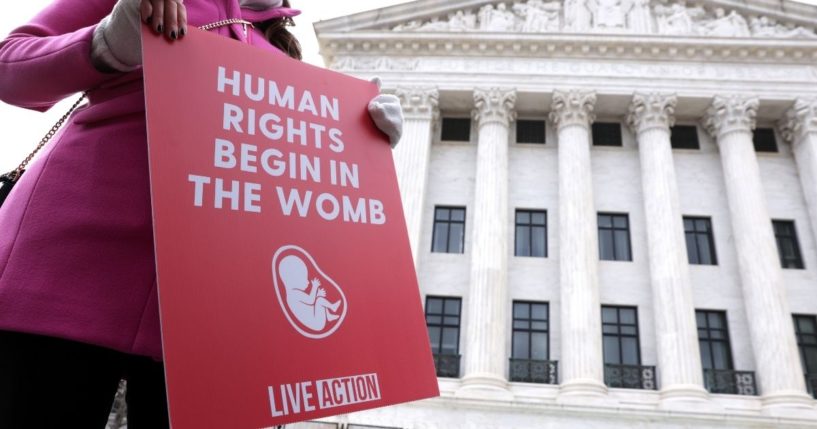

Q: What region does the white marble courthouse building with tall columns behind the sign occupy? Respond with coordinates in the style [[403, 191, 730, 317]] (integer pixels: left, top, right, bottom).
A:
[[308, 0, 817, 429]]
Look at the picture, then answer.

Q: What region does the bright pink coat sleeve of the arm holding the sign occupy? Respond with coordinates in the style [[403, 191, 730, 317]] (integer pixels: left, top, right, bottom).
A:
[[0, 0, 118, 111]]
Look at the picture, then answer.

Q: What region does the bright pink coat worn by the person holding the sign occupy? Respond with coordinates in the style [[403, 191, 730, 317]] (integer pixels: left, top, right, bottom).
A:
[[0, 0, 283, 359]]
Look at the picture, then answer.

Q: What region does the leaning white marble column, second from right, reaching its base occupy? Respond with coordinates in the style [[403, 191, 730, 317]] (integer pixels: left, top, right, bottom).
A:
[[704, 96, 811, 409]]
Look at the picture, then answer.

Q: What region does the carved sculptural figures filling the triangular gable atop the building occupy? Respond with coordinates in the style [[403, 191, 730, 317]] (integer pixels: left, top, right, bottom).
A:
[[391, 0, 817, 39]]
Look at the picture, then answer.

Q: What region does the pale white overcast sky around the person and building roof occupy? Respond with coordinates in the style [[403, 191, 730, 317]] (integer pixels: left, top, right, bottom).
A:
[[0, 0, 817, 173]]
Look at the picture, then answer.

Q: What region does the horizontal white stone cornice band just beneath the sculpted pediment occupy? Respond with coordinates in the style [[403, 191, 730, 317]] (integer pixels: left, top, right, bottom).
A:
[[321, 32, 817, 65]]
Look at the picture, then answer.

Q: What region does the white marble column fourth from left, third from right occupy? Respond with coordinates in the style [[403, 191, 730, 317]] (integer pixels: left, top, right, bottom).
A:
[[627, 93, 707, 400]]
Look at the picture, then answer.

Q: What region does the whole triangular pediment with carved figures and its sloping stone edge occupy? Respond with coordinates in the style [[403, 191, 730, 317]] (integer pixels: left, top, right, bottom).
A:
[[315, 0, 817, 40]]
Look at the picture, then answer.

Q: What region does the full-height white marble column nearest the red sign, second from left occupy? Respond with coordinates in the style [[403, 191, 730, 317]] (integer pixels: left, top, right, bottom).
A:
[[462, 88, 516, 389]]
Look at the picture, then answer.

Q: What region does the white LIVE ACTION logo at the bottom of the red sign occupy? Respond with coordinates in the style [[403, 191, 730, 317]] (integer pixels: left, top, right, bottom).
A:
[[267, 373, 381, 417]]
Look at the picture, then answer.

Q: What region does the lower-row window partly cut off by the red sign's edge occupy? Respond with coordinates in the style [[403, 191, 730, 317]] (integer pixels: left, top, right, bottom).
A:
[[426, 296, 462, 377]]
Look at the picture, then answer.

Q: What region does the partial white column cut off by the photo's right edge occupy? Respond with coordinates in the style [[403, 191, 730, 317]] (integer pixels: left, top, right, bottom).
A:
[[780, 99, 817, 249]]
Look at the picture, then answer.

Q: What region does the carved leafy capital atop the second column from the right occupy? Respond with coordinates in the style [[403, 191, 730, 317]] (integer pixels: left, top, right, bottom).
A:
[[703, 95, 760, 140]]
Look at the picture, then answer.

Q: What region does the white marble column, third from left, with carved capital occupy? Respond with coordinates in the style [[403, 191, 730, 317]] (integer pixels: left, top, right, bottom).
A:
[[550, 90, 607, 394]]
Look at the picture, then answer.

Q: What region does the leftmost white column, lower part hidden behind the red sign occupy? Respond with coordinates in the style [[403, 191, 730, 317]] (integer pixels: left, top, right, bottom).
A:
[[393, 88, 439, 266]]
